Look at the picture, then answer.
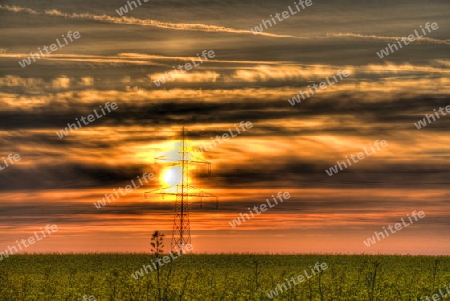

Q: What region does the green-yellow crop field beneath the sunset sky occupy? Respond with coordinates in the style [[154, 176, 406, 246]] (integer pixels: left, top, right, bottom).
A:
[[0, 254, 450, 301]]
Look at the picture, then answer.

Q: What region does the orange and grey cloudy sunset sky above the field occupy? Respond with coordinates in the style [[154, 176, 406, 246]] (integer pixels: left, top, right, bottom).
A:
[[0, 0, 450, 255]]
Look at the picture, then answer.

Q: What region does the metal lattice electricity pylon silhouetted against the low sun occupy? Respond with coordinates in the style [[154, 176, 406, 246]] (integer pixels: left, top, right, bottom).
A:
[[144, 126, 218, 253]]
